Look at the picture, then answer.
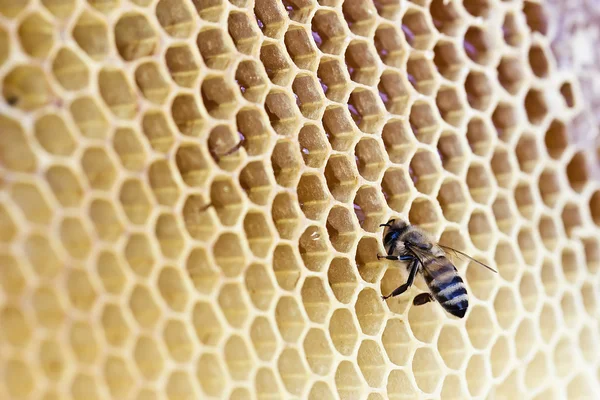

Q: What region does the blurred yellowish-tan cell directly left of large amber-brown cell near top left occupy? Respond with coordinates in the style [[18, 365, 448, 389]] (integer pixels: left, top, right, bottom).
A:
[[71, 11, 110, 60]]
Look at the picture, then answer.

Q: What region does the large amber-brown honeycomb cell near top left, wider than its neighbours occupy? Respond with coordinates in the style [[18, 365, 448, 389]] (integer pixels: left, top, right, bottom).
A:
[[114, 13, 158, 61]]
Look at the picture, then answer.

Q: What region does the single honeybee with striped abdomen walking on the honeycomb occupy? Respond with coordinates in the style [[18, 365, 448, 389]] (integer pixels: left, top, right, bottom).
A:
[[377, 219, 497, 318]]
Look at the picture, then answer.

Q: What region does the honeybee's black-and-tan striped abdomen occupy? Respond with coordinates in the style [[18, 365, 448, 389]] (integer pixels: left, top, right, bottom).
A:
[[423, 259, 469, 318]]
